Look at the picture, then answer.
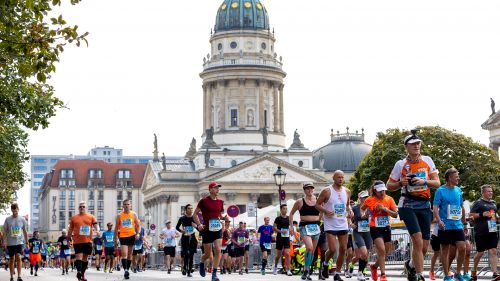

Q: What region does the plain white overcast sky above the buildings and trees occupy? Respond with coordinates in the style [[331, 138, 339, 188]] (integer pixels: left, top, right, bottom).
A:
[[1, 0, 500, 219]]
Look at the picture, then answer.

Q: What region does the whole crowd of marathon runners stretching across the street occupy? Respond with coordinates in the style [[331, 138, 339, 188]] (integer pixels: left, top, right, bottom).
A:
[[0, 133, 500, 281]]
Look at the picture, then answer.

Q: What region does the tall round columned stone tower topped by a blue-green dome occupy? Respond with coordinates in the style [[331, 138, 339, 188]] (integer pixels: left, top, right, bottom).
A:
[[200, 0, 286, 151]]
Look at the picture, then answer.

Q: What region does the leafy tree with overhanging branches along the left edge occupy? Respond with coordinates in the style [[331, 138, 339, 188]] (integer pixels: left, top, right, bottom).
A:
[[0, 0, 88, 210]]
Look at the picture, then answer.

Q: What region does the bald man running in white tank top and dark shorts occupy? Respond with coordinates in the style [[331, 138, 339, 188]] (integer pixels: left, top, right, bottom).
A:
[[316, 170, 354, 281]]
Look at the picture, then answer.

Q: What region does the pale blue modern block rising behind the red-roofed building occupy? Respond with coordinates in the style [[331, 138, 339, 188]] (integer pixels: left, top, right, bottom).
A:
[[29, 146, 153, 230]]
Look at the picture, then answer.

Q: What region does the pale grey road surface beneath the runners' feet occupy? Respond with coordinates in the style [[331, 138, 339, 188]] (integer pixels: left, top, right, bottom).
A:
[[0, 268, 489, 281]]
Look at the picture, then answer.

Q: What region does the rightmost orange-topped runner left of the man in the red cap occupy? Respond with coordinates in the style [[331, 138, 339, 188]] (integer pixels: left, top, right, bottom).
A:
[[115, 199, 141, 279]]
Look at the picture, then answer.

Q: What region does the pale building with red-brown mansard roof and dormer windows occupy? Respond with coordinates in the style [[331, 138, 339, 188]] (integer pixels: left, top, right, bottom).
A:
[[38, 160, 146, 241]]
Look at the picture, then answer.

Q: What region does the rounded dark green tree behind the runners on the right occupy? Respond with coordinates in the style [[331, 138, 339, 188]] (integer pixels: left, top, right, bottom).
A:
[[349, 127, 500, 207]]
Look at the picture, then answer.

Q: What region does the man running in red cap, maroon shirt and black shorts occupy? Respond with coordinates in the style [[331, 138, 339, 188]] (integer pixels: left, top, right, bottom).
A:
[[193, 182, 229, 281]]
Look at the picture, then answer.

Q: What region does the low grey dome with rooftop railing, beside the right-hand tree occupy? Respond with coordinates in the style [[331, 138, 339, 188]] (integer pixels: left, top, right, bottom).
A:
[[313, 127, 372, 180]]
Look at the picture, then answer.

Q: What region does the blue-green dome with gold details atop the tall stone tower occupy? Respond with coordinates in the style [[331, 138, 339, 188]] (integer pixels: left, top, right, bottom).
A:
[[215, 0, 269, 32]]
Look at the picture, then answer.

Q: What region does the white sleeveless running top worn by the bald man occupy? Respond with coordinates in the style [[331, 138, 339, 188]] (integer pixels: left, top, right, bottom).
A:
[[323, 185, 349, 231]]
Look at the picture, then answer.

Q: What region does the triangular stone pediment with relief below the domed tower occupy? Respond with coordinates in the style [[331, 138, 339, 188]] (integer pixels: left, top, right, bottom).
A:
[[204, 156, 326, 184]]
